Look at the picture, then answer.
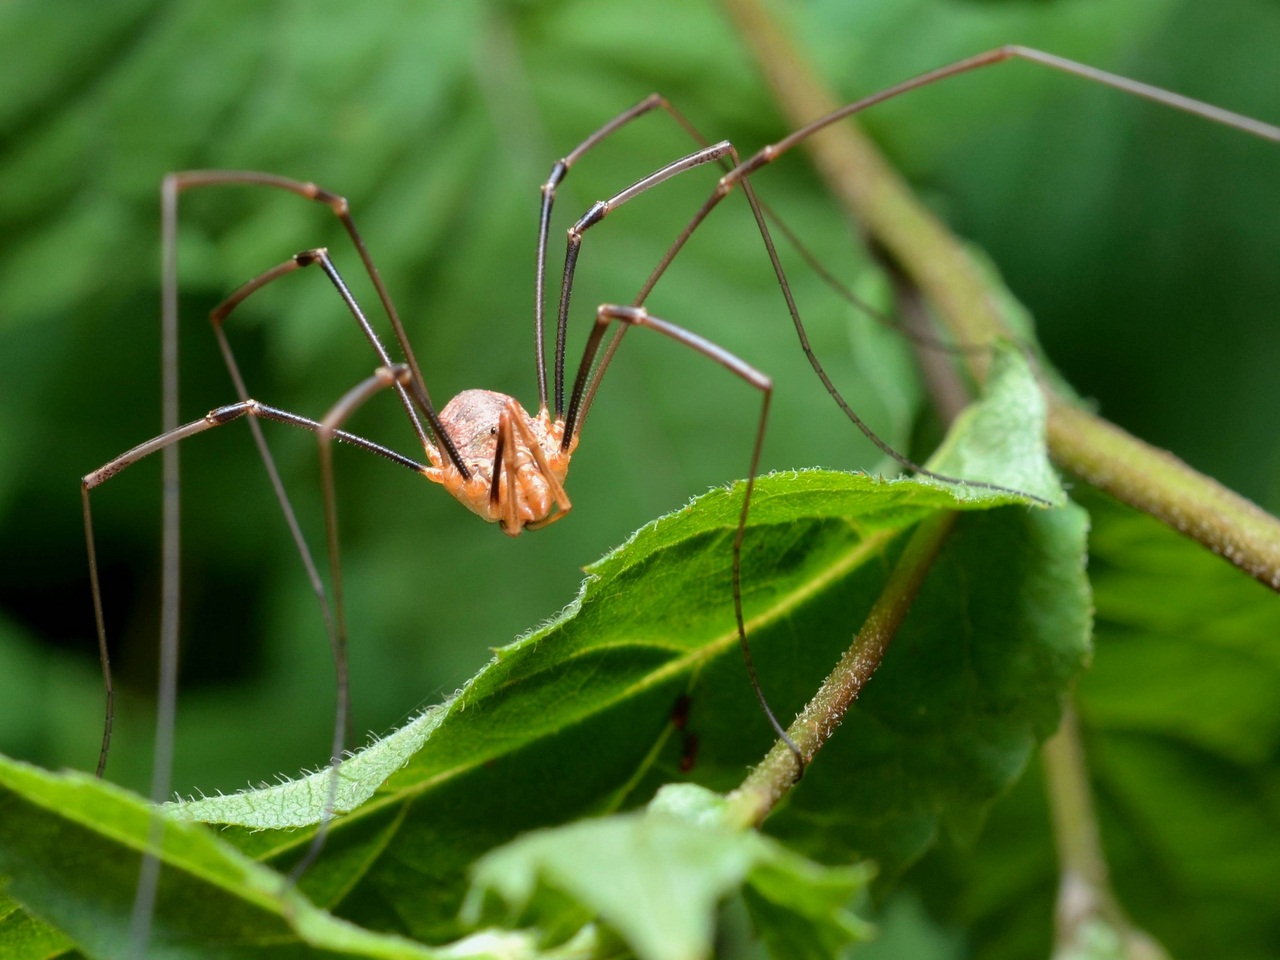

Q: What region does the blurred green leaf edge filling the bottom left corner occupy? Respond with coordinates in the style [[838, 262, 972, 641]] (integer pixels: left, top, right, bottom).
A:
[[0, 758, 524, 960]]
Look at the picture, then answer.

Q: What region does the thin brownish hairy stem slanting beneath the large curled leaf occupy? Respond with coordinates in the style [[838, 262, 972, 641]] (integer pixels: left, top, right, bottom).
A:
[[728, 512, 956, 827]]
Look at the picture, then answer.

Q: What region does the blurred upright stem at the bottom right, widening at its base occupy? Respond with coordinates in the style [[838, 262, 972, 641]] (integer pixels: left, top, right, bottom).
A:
[[1041, 707, 1167, 960]]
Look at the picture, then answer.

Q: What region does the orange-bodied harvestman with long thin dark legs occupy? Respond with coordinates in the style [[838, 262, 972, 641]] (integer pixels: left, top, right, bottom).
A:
[[82, 46, 1280, 957]]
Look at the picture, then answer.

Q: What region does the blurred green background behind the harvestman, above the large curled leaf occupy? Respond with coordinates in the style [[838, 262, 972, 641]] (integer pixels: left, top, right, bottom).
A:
[[0, 0, 1280, 957]]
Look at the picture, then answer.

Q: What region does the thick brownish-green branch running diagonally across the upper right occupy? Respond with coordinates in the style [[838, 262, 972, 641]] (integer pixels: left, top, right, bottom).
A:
[[722, 0, 1280, 591]]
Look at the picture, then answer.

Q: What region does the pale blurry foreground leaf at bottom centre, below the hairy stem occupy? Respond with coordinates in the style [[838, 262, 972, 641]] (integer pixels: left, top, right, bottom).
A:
[[466, 786, 870, 960]]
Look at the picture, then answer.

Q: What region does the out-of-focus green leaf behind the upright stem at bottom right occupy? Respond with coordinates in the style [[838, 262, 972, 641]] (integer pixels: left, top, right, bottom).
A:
[[910, 489, 1280, 960]]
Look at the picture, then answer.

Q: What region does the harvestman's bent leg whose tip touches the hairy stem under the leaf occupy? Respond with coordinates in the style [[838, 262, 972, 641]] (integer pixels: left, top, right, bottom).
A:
[[566, 303, 808, 778]]
